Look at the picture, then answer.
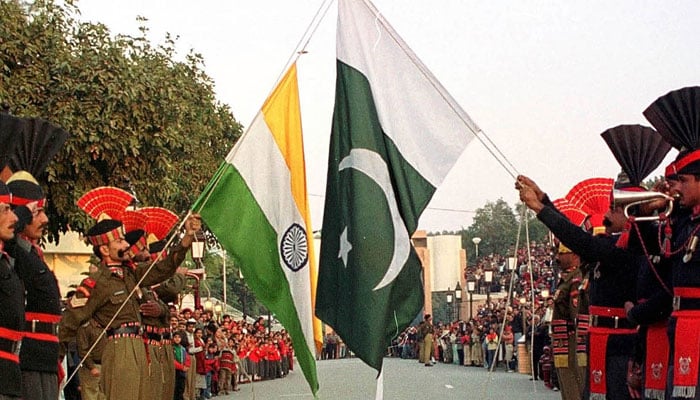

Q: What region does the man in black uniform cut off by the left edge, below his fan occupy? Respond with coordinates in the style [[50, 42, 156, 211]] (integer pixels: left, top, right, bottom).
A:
[[0, 182, 24, 400]]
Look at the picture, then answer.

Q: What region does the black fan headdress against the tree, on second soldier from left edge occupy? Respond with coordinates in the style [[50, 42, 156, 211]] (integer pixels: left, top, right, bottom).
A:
[[8, 118, 70, 179]]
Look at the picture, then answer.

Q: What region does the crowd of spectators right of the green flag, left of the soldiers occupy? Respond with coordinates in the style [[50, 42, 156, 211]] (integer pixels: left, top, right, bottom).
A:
[[388, 242, 559, 390]]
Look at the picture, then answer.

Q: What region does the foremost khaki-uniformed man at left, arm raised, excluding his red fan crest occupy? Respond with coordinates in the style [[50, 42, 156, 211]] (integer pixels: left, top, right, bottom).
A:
[[59, 211, 201, 400]]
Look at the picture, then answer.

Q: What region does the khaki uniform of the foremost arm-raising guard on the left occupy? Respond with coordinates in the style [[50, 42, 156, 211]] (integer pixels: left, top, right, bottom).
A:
[[59, 246, 186, 400]]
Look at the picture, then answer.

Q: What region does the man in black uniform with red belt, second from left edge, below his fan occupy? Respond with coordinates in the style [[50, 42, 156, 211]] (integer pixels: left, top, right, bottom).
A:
[[7, 171, 61, 400]]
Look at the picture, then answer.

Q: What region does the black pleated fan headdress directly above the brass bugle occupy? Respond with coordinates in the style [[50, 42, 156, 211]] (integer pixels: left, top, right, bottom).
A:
[[600, 125, 671, 189]]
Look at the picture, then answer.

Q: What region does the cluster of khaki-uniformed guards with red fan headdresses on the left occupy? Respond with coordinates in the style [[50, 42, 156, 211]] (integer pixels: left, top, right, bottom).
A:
[[59, 187, 201, 400]]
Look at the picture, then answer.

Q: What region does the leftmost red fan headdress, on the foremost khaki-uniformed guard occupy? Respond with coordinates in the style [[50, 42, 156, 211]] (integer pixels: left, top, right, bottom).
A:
[[75, 186, 134, 221]]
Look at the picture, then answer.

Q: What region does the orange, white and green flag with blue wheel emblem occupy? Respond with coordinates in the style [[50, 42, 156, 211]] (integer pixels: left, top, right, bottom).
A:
[[193, 64, 318, 394]]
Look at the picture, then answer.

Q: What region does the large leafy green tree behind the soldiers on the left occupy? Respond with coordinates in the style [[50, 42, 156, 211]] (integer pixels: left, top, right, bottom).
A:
[[0, 0, 241, 240]]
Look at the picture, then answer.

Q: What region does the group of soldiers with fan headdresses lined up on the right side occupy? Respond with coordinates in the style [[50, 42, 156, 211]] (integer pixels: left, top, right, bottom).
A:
[[515, 87, 700, 400]]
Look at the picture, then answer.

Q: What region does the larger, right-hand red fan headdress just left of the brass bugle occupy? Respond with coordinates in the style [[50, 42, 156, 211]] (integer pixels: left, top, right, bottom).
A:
[[565, 178, 614, 230]]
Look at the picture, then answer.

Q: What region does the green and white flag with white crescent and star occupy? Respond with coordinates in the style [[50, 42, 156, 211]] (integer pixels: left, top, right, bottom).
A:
[[316, 0, 478, 371]]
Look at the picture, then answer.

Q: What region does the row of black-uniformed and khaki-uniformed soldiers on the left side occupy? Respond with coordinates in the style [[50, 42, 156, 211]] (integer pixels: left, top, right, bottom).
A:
[[0, 171, 201, 400]]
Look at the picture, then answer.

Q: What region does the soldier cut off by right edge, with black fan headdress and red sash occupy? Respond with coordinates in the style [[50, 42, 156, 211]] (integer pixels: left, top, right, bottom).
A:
[[644, 86, 700, 399]]
